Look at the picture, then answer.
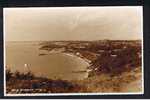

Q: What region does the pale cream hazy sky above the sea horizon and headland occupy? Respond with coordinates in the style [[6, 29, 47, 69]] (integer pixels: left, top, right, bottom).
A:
[[4, 6, 143, 41]]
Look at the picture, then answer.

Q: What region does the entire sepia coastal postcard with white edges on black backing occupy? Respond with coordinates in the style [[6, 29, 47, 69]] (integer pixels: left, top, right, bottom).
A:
[[3, 6, 144, 96]]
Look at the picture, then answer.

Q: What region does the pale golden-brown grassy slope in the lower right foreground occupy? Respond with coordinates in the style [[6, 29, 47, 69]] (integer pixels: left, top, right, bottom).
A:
[[75, 68, 142, 92]]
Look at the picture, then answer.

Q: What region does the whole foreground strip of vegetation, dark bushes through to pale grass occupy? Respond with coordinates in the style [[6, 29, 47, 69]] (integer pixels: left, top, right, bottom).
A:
[[6, 67, 141, 94]]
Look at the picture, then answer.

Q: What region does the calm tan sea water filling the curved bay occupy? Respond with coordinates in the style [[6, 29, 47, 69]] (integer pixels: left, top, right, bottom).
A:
[[6, 42, 88, 80]]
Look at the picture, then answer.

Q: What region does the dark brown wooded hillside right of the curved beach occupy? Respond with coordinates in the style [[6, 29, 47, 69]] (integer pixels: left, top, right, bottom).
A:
[[91, 47, 141, 74]]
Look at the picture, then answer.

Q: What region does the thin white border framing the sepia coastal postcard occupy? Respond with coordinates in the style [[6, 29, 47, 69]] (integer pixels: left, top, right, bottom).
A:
[[3, 6, 144, 96]]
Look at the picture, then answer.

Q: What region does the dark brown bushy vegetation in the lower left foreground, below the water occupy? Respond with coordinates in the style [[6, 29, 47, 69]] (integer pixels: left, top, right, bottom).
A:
[[6, 69, 84, 93]]
